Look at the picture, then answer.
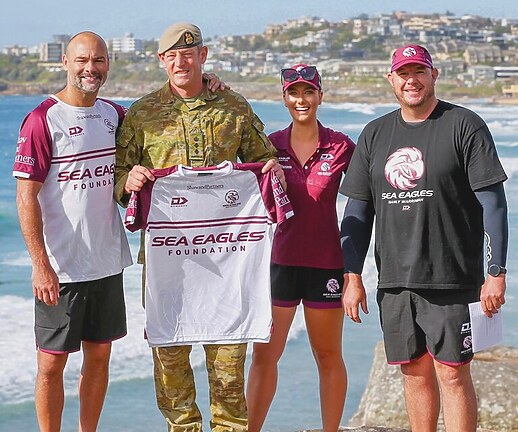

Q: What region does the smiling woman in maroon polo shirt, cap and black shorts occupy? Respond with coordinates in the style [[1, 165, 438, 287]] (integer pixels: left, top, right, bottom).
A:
[[247, 64, 355, 432]]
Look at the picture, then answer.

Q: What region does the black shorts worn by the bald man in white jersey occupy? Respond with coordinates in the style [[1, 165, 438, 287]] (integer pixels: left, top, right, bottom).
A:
[[34, 273, 126, 354]]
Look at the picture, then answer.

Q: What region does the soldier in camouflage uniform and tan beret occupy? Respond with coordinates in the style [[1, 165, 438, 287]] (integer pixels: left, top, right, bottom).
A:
[[115, 23, 284, 432]]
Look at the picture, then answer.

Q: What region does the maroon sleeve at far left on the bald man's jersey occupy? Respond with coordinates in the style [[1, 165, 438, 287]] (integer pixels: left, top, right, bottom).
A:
[[13, 98, 58, 183]]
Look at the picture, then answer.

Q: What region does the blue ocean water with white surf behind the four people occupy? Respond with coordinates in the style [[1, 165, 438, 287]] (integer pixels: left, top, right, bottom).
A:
[[0, 96, 518, 432]]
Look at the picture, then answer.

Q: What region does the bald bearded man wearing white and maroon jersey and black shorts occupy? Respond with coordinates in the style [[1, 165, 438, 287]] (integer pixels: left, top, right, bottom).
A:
[[13, 32, 131, 432]]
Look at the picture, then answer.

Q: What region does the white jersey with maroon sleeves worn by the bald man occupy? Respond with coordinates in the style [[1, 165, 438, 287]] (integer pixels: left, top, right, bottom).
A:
[[13, 96, 132, 283]]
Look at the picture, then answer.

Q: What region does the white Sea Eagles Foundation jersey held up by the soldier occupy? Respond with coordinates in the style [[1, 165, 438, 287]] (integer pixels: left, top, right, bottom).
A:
[[125, 162, 293, 346]]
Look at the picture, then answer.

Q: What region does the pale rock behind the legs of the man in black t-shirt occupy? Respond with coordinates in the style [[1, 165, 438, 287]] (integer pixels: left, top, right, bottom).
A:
[[349, 342, 518, 432]]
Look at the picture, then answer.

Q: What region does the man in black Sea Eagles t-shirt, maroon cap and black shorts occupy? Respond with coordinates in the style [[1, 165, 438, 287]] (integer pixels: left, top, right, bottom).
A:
[[341, 45, 508, 432]]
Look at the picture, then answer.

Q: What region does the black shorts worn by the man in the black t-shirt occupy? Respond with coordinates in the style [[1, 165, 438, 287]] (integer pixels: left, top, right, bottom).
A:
[[377, 288, 479, 366]]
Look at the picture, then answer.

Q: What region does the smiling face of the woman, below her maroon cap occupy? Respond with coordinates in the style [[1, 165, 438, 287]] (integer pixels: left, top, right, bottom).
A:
[[283, 83, 323, 123]]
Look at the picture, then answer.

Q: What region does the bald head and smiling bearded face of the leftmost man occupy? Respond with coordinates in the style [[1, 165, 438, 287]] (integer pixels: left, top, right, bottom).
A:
[[63, 32, 110, 97]]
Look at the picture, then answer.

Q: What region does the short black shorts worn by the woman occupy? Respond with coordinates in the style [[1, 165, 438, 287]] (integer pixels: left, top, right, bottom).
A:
[[270, 263, 344, 309]]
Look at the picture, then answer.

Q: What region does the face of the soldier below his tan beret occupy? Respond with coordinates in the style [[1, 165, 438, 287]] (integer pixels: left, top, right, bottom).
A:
[[158, 46, 207, 98]]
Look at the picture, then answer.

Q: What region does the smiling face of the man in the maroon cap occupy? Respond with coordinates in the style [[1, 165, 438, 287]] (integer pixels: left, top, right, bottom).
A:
[[387, 63, 439, 111]]
